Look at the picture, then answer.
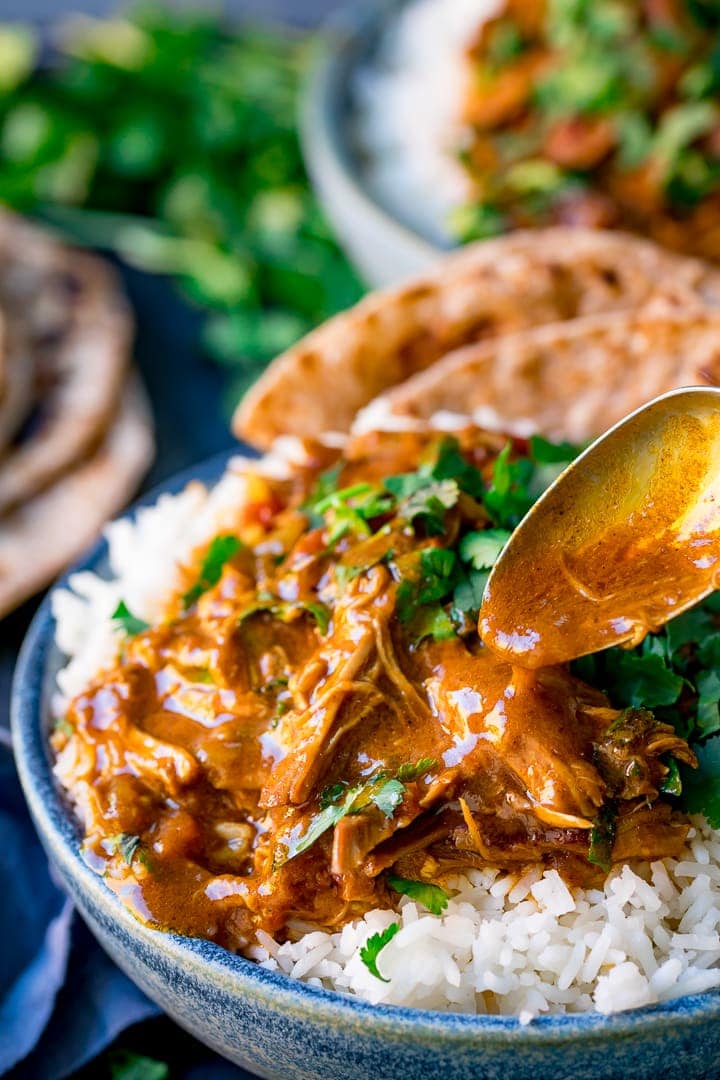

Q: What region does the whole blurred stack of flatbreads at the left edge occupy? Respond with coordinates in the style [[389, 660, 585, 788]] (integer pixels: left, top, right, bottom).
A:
[[0, 214, 153, 617]]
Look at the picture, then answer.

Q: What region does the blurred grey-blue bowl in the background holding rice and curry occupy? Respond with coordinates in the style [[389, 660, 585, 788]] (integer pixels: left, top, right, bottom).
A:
[[300, 0, 447, 287]]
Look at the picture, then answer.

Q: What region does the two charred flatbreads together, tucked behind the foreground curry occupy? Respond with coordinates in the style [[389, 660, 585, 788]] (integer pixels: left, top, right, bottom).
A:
[[233, 228, 720, 449]]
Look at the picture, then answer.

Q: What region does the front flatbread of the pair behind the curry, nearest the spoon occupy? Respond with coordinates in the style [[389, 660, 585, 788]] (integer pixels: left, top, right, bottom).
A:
[[354, 311, 720, 442]]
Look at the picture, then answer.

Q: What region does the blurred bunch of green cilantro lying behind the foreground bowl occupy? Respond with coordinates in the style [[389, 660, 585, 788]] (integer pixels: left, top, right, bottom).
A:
[[0, 4, 362, 397]]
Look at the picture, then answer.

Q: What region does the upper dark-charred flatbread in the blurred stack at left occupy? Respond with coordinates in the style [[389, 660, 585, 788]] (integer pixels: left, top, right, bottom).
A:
[[0, 215, 132, 514]]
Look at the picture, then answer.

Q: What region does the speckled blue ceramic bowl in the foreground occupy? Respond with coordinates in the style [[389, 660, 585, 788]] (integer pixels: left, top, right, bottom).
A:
[[13, 455, 720, 1080]]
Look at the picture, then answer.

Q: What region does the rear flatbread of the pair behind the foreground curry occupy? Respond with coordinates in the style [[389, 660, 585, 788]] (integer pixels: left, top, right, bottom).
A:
[[233, 228, 720, 448]]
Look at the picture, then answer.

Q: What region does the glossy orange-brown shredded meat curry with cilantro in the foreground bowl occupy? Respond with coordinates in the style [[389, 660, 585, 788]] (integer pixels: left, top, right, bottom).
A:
[[52, 428, 695, 949]]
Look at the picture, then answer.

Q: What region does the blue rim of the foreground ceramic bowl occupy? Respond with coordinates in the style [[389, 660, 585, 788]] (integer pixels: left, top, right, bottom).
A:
[[11, 450, 720, 1036]]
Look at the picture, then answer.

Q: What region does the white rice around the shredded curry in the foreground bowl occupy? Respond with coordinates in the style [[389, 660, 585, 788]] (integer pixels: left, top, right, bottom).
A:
[[53, 453, 720, 1023]]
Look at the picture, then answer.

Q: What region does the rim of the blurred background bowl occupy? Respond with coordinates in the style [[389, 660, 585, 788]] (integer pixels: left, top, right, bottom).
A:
[[298, 0, 444, 259]]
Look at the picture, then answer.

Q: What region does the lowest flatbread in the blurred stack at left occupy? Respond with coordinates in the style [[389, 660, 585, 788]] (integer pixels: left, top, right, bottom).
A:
[[0, 383, 153, 618]]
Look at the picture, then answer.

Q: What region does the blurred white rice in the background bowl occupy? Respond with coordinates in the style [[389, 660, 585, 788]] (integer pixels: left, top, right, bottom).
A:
[[353, 0, 492, 243]]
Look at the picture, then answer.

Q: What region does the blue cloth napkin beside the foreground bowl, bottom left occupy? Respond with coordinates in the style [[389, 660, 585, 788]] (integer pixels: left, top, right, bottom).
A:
[[0, 746, 159, 1080]]
